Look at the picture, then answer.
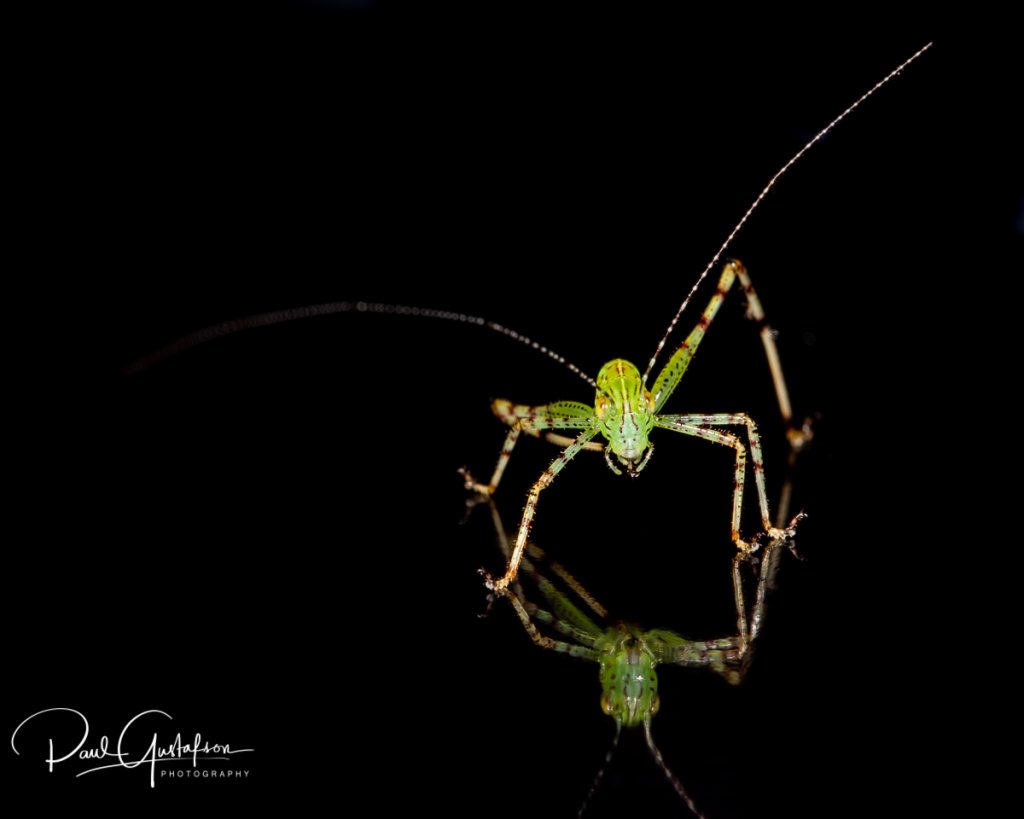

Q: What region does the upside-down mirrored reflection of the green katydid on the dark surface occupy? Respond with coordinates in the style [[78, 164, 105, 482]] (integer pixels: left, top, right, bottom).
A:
[[490, 502, 801, 817]]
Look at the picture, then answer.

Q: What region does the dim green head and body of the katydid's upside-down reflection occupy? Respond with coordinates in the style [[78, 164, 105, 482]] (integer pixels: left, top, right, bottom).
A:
[[601, 627, 658, 726]]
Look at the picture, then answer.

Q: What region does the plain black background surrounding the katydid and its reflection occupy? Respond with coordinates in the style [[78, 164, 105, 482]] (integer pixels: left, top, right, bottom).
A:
[[2, 3, 1021, 819]]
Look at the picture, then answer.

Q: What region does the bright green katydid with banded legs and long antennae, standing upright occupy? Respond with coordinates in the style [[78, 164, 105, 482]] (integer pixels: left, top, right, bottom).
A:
[[125, 43, 931, 591]]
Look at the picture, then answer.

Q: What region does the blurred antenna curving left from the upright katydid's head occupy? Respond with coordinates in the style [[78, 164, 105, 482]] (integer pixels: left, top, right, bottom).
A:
[[121, 301, 597, 389]]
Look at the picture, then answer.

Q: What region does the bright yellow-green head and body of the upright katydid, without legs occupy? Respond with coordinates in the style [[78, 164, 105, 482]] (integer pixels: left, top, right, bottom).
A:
[[594, 358, 654, 472]]
